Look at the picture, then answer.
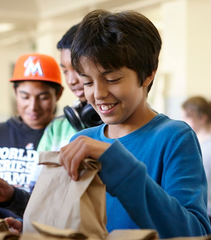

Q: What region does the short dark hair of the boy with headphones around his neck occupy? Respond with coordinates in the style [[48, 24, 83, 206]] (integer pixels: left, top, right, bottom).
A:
[[57, 23, 79, 50]]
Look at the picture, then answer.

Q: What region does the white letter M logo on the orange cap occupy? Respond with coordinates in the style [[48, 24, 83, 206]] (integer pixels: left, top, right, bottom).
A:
[[24, 57, 44, 77]]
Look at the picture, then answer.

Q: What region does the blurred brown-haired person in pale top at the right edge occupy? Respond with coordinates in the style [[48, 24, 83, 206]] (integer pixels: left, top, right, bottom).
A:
[[182, 96, 211, 221]]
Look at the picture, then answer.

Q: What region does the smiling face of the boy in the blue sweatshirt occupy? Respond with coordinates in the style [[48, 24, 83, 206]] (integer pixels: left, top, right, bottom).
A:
[[80, 57, 152, 128]]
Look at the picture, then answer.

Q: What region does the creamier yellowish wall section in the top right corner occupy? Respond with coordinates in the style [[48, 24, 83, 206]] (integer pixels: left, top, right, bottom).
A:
[[187, 0, 211, 100]]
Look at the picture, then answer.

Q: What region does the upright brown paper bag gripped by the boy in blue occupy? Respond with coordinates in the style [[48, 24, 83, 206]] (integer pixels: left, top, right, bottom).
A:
[[23, 152, 108, 239]]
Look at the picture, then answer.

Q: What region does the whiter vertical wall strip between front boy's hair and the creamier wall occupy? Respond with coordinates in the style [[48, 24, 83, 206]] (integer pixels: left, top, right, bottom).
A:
[[157, 0, 187, 118]]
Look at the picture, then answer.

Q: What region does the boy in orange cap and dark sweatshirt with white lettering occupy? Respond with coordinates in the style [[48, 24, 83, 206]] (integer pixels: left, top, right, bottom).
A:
[[0, 53, 63, 218]]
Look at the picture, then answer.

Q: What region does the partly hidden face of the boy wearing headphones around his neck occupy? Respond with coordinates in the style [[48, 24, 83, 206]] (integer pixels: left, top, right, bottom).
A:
[[60, 49, 86, 102]]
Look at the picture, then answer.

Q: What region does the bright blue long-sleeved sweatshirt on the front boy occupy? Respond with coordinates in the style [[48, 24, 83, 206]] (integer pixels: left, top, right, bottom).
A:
[[71, 114, 211, 238]]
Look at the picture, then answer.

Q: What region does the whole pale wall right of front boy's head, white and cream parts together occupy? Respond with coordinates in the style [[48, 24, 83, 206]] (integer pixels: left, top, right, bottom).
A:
[[150, 0, 211, 119]]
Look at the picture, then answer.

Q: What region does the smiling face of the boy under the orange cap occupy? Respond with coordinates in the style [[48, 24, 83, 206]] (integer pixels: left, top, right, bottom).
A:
[[15, 81, 60, 129]]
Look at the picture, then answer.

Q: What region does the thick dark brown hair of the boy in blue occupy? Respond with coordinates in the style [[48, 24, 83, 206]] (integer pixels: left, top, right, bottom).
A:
[[71, 10, 162, 92]]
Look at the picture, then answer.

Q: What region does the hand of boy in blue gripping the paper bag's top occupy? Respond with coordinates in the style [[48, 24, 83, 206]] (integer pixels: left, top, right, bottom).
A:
[[60, 136, 110, 180]]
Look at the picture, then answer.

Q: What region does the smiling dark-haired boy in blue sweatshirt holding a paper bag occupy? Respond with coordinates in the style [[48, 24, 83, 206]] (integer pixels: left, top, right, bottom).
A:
[[55, 10, 211, 238]]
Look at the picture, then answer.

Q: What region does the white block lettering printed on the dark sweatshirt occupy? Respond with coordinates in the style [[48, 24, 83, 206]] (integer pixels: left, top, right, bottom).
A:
[[0, 143, 38, 191]]
